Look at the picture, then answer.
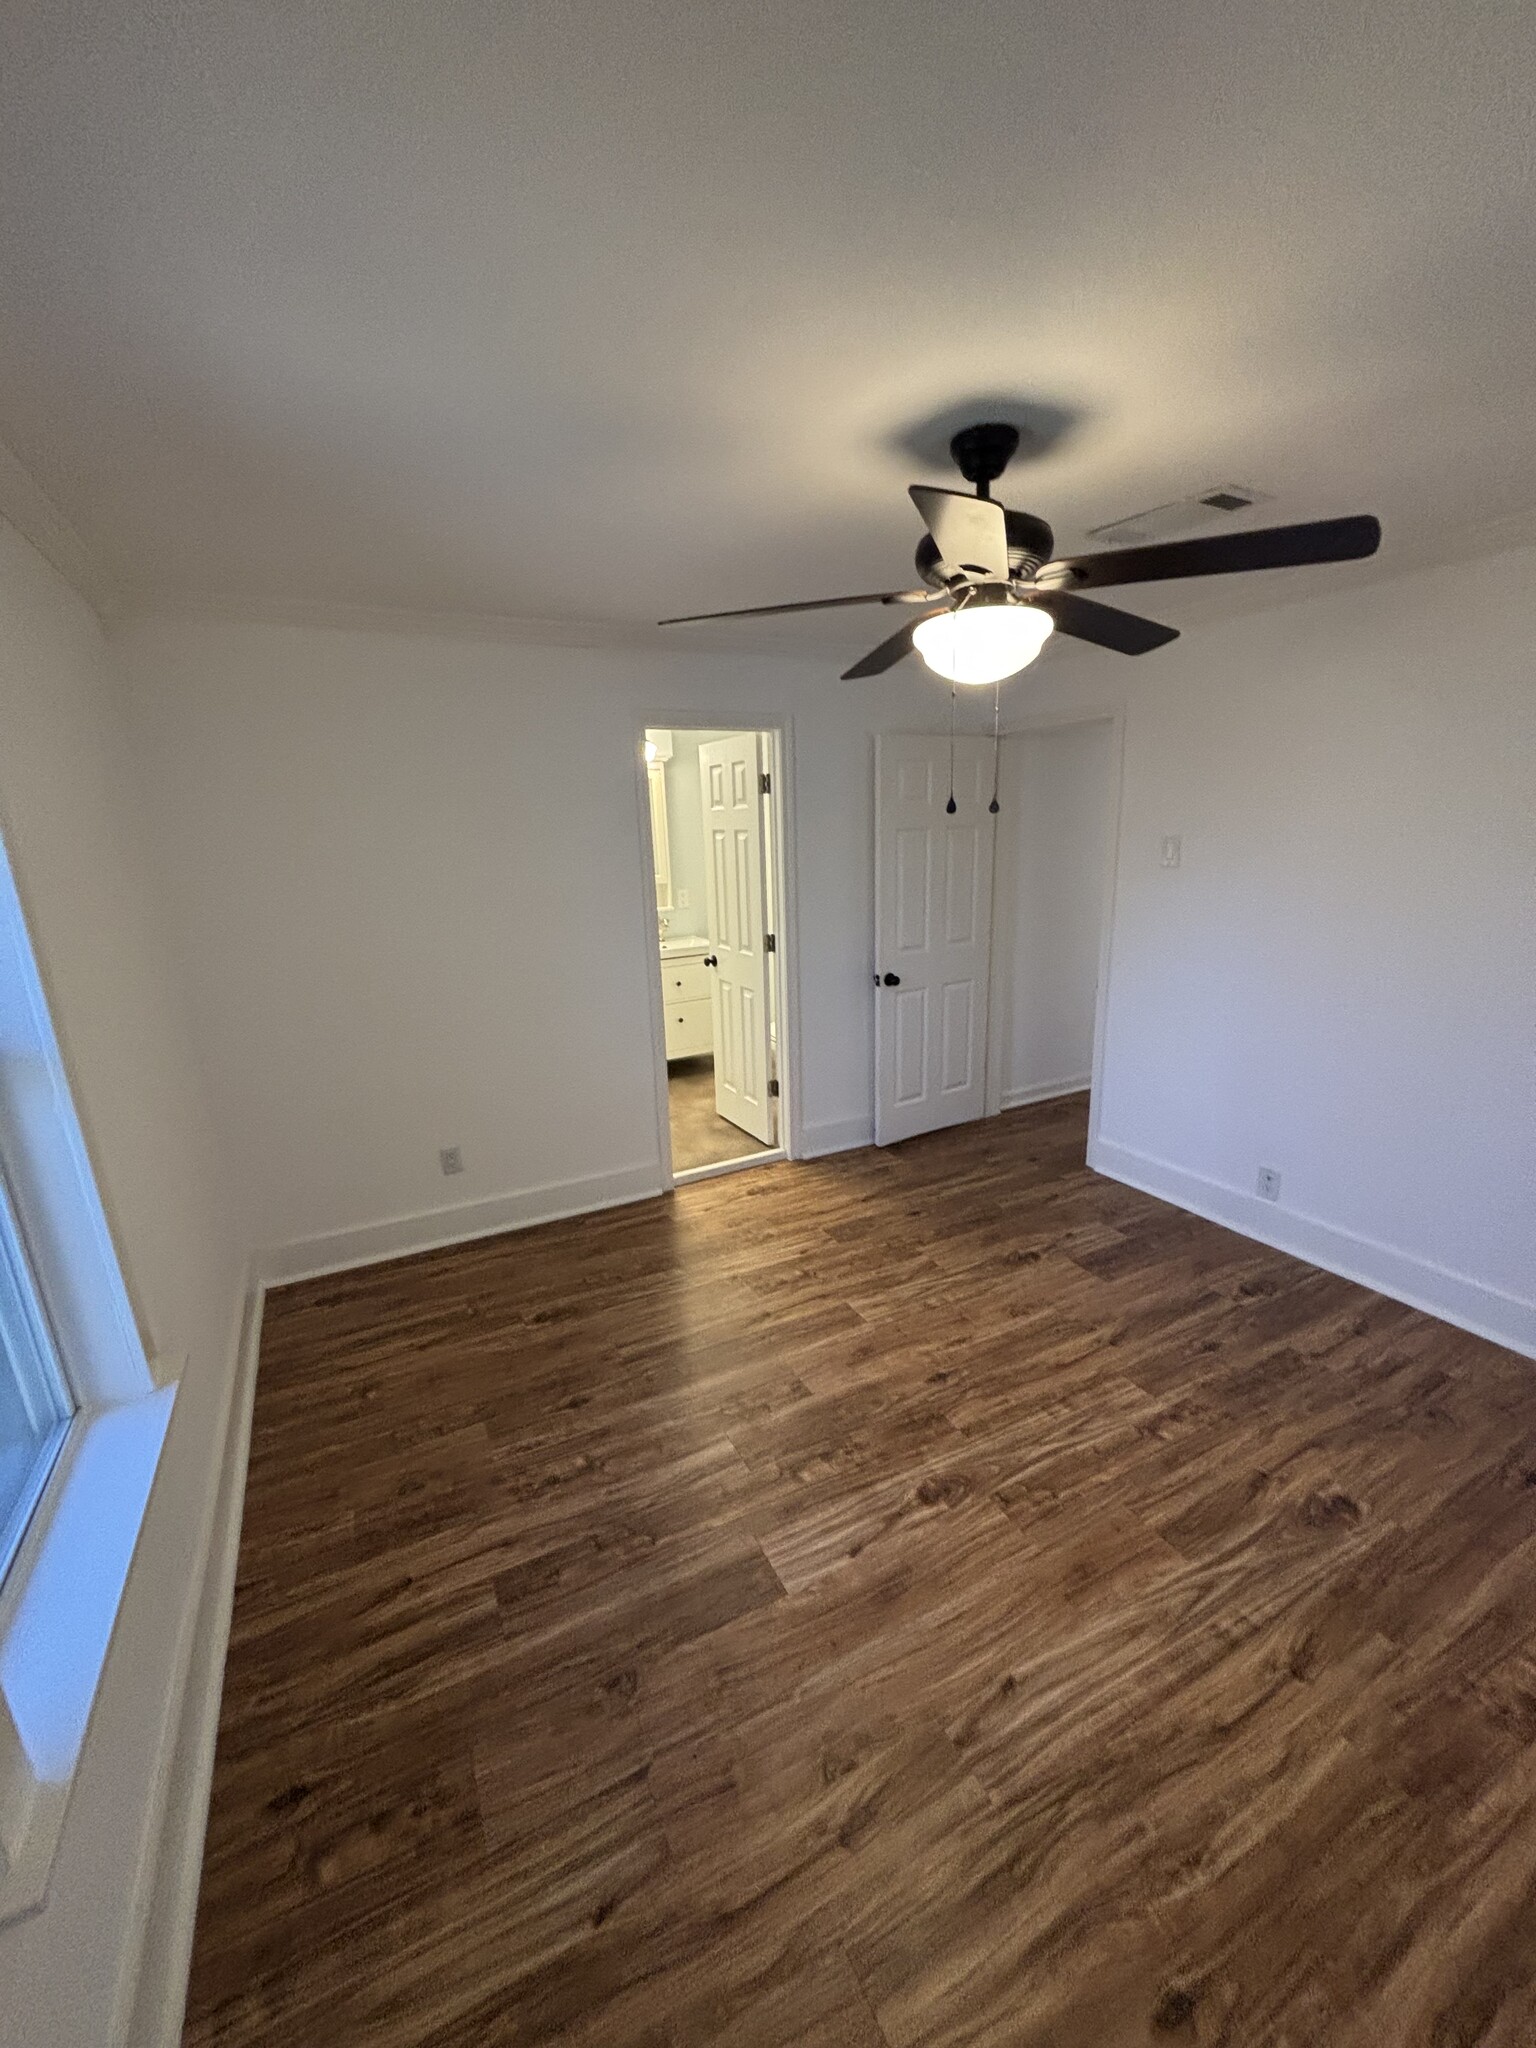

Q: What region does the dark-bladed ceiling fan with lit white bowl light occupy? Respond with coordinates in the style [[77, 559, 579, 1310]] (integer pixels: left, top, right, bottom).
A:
[[659, 422, 1380, 684]]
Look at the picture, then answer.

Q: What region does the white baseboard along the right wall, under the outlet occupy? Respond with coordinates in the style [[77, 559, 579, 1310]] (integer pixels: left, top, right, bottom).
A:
[[1087, 1139, 1536, 1358]]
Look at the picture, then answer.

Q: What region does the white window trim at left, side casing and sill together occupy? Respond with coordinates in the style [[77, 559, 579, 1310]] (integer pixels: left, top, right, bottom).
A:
[[0, 831, 176, 1925]]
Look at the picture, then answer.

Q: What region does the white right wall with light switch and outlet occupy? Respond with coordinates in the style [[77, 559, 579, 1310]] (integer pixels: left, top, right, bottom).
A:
[[1092, 551, 1536, 1350]]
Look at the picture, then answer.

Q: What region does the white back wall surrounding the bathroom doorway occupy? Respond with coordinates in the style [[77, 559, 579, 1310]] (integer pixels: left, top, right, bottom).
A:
[[117, 621, 1102, 1270]]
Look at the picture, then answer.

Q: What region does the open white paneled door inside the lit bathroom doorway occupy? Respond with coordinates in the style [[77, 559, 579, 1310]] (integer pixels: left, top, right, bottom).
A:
[[698, 733, 774, 1145]]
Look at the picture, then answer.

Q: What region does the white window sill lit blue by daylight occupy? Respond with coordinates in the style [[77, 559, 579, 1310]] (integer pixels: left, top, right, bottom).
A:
[[0, 1386, 176, 1925]]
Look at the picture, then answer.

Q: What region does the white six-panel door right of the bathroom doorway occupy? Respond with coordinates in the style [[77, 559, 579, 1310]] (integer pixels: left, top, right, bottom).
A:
[[874, 733, 995, 1145]]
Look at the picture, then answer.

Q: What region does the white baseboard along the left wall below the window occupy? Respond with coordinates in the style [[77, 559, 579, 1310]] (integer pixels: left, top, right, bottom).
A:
[[123, 1282, 266, 2048]]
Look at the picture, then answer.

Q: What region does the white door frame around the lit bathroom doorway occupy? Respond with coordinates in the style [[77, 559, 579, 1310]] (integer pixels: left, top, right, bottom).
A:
[[635, 709, 801, 1194]]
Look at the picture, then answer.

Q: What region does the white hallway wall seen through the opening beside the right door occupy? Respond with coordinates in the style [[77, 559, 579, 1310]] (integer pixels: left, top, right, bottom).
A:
[[993, 719, 1118, 1108]]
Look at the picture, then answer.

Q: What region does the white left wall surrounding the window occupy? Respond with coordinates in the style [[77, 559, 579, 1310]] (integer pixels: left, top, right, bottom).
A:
[[0, 522, 246, 2048]]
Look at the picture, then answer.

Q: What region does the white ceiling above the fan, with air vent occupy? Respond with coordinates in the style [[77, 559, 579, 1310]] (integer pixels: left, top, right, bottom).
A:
[[0, 0, 1536, 651]]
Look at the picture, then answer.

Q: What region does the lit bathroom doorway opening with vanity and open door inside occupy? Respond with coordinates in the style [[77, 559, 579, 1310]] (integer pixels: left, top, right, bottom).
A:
[[643, 725, 788, 1182]]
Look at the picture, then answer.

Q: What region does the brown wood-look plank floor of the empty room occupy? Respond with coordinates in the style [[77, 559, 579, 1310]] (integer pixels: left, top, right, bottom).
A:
[[186, 1102, 1536, 2048]]
